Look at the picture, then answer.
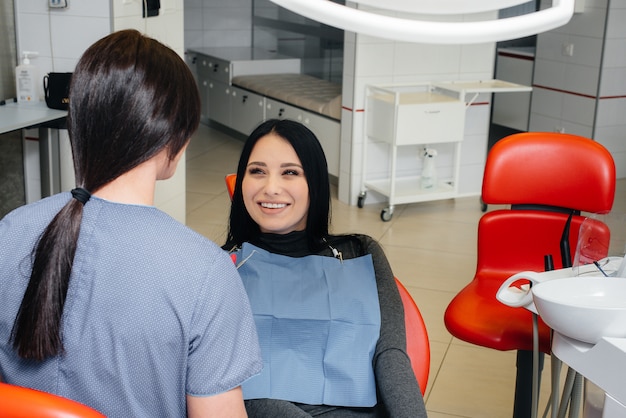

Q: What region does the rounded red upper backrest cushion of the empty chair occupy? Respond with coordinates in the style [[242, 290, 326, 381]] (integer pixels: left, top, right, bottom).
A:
[[482, 132, 615, 213]]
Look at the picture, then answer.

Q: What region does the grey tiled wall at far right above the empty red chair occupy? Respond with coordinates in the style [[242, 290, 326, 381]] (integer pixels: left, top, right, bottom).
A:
[[530, 0, 626, 178]]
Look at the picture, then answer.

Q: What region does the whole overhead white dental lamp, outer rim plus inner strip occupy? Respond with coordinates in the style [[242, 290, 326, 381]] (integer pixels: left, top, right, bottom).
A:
[[270, 0, 575, 44]]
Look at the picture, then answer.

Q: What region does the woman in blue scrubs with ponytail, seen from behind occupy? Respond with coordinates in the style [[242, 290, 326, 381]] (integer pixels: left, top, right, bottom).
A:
[[0, 30, 262, 418]]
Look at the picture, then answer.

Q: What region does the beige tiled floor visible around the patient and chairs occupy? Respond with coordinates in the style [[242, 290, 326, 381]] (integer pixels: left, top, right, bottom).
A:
[[187, 125, 626, 418]]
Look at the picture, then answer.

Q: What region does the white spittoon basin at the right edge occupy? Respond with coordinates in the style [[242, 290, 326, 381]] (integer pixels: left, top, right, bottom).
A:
[[532, 277, 626, 344]]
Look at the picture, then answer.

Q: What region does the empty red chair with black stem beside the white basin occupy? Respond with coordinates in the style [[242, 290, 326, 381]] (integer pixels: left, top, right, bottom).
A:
[[444, 132, 615, 417]]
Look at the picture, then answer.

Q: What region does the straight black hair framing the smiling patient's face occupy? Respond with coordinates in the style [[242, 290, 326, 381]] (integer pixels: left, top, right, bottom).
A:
[[225, 119, 330, 250]]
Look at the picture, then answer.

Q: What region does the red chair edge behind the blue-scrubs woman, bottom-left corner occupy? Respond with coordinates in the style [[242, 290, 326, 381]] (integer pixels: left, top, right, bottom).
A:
[[0, 383, 105, 418]]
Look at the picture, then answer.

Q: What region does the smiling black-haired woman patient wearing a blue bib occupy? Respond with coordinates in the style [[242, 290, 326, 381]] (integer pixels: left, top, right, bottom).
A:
[[223, 120, 426, 418]]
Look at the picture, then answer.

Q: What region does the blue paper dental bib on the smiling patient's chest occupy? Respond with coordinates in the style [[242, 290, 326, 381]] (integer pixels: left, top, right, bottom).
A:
[[237, 243, 380, 407]]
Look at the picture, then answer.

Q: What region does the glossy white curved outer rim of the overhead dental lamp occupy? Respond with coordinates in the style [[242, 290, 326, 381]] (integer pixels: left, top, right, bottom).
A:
[[271, 0, 575, 44]]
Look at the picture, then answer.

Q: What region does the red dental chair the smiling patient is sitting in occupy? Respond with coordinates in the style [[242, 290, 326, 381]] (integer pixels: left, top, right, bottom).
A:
[[224, 174, 430, 396]]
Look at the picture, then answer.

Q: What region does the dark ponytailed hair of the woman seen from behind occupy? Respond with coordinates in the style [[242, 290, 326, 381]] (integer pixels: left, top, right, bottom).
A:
[[11, 30, 200, 360]]
